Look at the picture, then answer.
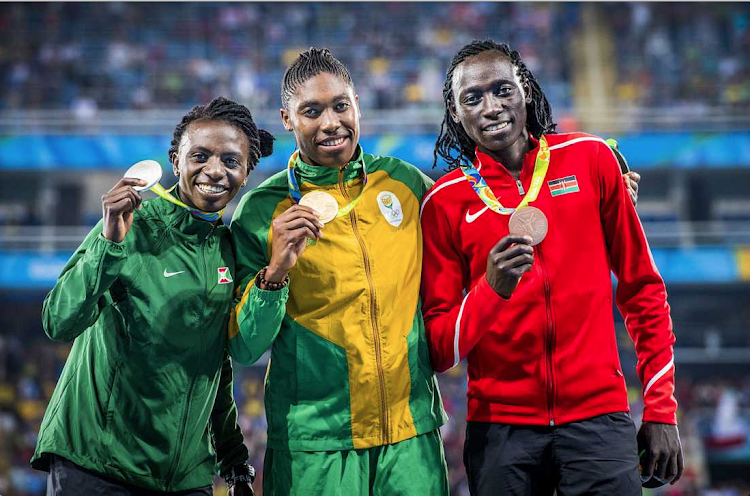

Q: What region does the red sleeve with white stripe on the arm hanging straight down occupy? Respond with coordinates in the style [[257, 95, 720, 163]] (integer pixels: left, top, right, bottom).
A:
[[598, 144, 677, 424]]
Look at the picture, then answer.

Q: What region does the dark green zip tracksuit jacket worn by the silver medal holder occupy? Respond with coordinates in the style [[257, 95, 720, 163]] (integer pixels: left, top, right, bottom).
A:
[[32, 194, 258, 491]]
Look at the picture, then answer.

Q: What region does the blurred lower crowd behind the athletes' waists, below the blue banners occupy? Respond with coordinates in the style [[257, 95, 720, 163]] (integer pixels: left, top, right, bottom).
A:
[[0, 330, 750, 496]]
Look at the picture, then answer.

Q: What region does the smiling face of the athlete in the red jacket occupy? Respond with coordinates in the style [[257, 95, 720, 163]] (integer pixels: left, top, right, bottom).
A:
[[449, 50, 531, 158]]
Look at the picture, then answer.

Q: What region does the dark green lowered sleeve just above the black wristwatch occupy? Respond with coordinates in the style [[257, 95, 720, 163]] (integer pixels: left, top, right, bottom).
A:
[[211, 351, 249, 474]]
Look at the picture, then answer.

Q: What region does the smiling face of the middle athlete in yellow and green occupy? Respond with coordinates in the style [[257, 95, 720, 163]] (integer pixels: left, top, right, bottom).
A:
[[281, 72, 359, 167]]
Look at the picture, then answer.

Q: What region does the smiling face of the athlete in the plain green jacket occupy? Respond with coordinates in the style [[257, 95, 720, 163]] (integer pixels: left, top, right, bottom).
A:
[[172, 121, 249, 212]]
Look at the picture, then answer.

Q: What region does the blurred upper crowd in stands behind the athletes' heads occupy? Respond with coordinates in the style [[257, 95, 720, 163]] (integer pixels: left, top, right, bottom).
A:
[[0, 2, 750, 118]]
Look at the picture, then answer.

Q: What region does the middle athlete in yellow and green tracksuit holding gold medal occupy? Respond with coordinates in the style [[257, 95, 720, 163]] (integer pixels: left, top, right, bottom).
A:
[[229, 49, 448, 496]]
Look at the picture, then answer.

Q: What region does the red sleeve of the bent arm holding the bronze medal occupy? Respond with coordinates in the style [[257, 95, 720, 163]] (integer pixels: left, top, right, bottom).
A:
[[422, 190, 507, 372]]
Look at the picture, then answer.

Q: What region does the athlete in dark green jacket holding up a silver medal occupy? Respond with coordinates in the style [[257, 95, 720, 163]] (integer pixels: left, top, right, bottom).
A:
[[31, 98, 273, 496]]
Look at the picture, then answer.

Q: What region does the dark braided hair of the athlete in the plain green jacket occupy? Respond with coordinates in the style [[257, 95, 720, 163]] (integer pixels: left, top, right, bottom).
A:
[[169, 96, 276, 172]]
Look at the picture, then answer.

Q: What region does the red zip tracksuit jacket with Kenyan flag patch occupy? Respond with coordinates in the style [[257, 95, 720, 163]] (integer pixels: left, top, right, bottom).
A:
[[421, 133, 677, 425]]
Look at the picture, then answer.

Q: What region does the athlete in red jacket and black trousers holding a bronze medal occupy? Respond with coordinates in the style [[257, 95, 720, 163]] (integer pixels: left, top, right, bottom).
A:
[[422, 41, 682, 495]]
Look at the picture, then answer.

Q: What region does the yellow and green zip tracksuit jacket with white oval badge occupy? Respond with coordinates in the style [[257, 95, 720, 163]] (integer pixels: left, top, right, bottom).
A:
[[229, 148, 446, 451]]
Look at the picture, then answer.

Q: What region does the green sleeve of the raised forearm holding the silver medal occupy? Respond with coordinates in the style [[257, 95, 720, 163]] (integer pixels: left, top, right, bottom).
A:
[[42, 221, 127, 341]]
